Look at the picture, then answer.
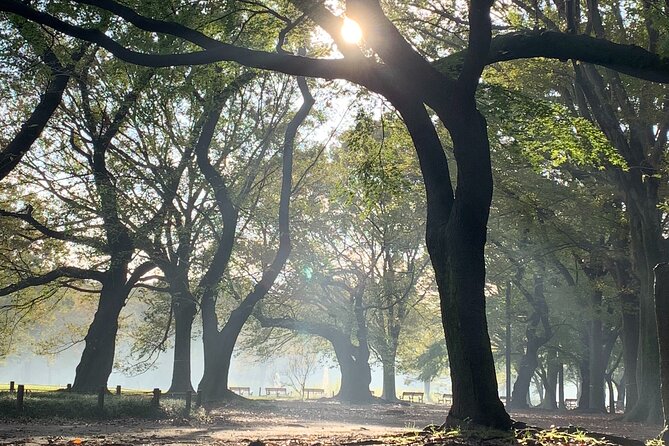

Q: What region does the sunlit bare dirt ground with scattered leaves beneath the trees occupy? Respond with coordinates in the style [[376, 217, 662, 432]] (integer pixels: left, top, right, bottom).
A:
[[0, 401, 660, 446]]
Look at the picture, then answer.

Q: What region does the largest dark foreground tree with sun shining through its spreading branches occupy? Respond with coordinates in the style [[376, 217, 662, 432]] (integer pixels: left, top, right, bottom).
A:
[[6, 0, 669, 429]]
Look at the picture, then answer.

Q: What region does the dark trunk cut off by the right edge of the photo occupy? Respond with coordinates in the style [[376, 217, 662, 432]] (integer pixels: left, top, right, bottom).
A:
[[654, 263, 669, 444]]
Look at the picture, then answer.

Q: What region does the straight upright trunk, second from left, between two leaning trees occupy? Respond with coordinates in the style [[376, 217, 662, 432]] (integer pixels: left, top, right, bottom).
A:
[[168, 291, 197, 393]]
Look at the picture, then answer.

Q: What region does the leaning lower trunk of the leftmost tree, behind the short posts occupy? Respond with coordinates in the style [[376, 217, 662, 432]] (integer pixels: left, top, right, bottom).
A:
[[72, 275, 128, 393]]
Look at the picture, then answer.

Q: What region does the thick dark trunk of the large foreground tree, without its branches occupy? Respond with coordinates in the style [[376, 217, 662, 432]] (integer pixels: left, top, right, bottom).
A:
[[428, 109, 511, 429]]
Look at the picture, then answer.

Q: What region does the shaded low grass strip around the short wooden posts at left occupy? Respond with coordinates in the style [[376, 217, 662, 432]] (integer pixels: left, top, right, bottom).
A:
[[0, 387, 193, 420]]
